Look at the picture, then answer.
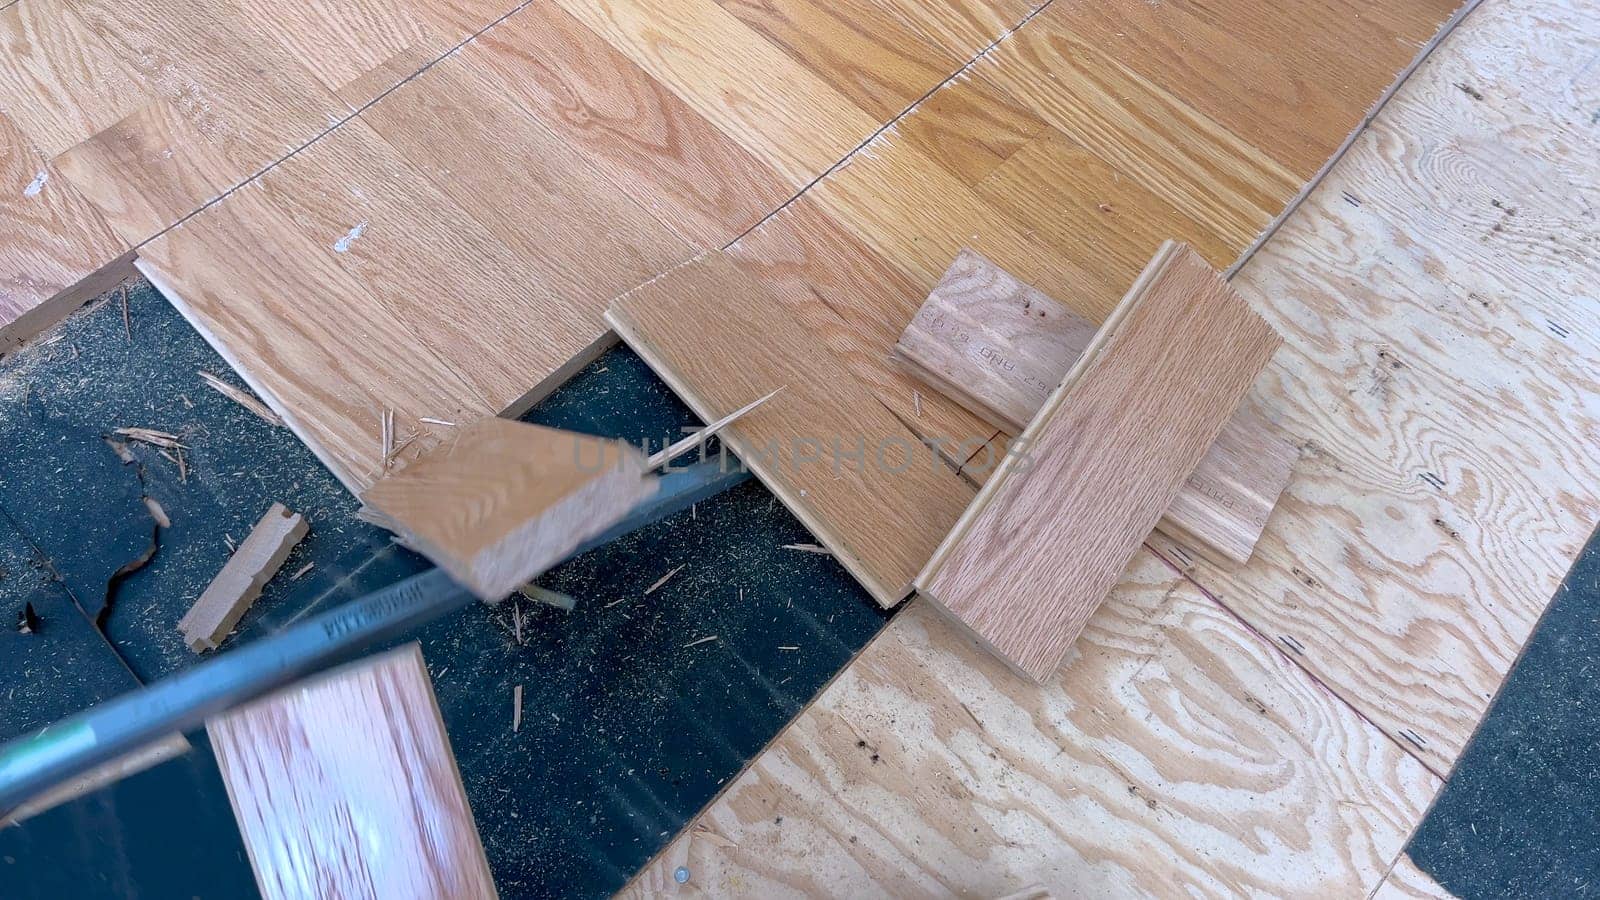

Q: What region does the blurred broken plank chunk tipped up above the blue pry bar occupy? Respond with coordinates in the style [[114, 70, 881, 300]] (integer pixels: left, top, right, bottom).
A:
[[360, 416, 658, 602]]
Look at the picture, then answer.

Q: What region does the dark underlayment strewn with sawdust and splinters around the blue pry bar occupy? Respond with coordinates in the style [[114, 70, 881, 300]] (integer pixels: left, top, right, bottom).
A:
[[0, 282, 886, 898]]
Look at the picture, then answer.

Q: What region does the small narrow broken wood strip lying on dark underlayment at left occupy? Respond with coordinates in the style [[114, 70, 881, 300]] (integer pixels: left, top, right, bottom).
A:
[[178, 503, 310, 653]]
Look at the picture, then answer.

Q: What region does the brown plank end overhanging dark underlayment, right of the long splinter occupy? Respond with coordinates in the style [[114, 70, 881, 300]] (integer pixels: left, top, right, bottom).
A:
[[606, 253, 971, 607]]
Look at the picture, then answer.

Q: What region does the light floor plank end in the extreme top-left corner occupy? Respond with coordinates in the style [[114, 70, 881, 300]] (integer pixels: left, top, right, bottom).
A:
[[0, 0, 144, 159]]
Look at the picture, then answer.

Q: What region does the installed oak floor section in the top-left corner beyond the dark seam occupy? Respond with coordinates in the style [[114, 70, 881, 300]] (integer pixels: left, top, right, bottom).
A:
[[0, 0, 515, 346]]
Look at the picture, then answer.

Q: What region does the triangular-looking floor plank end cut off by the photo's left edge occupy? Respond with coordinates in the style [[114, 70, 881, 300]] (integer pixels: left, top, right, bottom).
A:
[[0, 114, 133, 352]]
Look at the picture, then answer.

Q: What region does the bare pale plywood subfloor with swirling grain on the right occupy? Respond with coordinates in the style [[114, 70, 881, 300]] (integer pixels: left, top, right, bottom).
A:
[[614, 0, 1600, 895]]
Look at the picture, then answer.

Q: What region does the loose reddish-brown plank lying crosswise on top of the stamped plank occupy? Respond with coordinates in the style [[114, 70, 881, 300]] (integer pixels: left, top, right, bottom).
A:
[[917, 242, 1282, 681]]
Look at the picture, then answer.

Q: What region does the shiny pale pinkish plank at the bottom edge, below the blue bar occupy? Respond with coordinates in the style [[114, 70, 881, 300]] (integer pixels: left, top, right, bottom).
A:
[[206, 644, 496, 900]]
